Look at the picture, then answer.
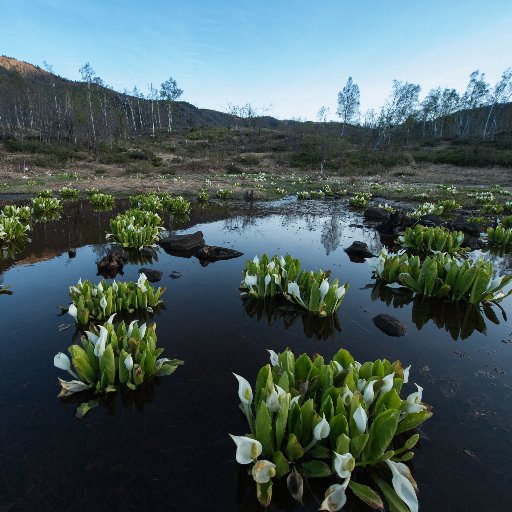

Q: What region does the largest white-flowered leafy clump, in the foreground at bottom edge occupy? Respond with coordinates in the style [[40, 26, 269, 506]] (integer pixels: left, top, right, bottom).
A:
[[230, 349, 432, 511]]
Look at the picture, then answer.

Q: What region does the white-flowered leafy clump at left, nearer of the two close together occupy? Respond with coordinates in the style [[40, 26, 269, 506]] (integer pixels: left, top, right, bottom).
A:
[[53, 320, 183, 418]]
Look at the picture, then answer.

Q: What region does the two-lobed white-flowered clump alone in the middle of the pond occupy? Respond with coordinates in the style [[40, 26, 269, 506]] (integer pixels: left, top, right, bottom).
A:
[[242, 254, 348, 317]]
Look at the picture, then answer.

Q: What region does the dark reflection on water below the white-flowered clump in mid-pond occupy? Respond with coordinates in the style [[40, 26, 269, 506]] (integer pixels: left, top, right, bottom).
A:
[[242, 296, 341, 340]]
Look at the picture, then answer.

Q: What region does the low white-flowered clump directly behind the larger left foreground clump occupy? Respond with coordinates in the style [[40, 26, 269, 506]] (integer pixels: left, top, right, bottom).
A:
[[68, 274, 165, 325]]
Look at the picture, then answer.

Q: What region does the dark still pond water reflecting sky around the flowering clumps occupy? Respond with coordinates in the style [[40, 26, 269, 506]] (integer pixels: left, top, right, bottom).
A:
[[0, 201, 512, 512]]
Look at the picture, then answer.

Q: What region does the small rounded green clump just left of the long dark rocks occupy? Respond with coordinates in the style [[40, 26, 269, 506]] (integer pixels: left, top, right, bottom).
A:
[[107, 209, 164, 249]]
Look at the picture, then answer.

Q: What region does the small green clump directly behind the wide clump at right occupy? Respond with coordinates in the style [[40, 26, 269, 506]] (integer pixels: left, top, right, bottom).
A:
[[398, 224, 464, 254]]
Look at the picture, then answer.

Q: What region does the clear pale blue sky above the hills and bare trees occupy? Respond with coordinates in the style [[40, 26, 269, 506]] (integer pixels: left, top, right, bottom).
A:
[[0, 0, 512, 120]]
